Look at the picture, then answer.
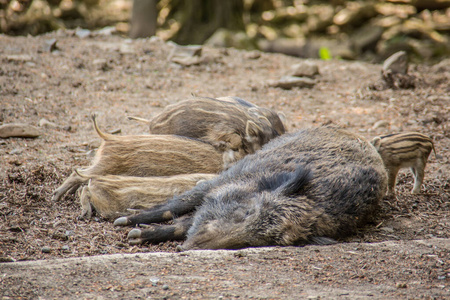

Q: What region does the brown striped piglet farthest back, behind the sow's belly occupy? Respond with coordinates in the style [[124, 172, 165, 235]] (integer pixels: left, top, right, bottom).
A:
[[129, 97, 285, 167]]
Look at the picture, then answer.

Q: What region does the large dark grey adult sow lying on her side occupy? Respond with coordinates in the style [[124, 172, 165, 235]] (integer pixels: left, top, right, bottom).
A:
[[114, 127, 387, 250]]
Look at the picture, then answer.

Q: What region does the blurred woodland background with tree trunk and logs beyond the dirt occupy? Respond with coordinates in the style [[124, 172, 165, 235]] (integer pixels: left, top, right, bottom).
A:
[[0, 0, 450, 62]]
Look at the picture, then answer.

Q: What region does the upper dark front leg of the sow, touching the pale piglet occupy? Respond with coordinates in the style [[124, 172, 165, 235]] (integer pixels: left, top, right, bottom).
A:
[[114, 181, 210, 226]]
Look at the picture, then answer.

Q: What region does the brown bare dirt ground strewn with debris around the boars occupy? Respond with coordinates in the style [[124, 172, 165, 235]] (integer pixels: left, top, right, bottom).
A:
[[0, 31, 450, 299]]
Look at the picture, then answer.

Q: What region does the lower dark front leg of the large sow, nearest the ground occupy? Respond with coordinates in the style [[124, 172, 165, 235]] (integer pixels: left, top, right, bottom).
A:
[[127, 215, 193, 245]]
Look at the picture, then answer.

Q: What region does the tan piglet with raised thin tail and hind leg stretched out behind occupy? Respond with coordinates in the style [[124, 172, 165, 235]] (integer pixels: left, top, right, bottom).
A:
[[53, 116, 224, 200]]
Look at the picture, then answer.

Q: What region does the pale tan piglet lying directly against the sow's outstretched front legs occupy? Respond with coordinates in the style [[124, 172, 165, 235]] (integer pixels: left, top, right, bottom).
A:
[[76, 171, 217, 219]]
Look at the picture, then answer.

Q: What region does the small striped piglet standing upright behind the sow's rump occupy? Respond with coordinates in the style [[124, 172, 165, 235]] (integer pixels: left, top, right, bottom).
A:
[[372, 132, 436, 195]]
